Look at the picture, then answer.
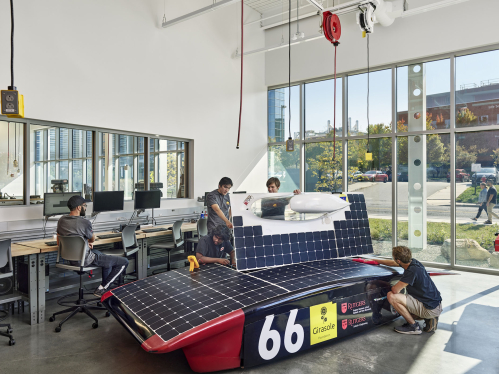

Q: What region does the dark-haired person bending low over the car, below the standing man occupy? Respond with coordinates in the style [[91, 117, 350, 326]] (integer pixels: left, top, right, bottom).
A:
[[196, 224, 236, 266]]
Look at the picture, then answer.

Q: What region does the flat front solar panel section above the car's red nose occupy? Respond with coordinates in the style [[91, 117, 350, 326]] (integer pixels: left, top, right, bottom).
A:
[[112, 265, 287, 341]]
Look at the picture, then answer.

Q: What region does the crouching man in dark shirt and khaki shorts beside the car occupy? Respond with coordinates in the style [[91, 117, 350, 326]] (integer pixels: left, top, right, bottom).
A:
[[376, 246, 442, 335]]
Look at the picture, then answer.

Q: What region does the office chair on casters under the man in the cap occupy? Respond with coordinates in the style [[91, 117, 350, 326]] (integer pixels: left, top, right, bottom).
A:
[[49, 236, 110, 332]]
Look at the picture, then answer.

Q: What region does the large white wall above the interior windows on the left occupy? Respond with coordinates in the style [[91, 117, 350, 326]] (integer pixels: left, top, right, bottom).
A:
[[0, 0, 267, 221]]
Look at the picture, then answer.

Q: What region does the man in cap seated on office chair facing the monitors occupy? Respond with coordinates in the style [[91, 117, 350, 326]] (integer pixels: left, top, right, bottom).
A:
[[57, 196, 128, 297]]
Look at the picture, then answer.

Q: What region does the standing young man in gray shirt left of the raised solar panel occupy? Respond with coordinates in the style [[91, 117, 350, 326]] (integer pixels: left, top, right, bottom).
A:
[[206, 177, 232, 232]]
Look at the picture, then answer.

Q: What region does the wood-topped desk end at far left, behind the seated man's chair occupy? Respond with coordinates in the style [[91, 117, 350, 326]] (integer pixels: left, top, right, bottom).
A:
[[9, 243, 40, 325]]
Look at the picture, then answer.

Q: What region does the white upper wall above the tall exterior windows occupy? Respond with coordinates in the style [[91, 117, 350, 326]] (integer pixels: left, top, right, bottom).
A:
[[268, 0, 499, 86]]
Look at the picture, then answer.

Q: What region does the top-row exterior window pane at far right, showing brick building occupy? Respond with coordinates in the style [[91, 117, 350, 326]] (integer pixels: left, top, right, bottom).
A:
[[456, 50, 499, 127]]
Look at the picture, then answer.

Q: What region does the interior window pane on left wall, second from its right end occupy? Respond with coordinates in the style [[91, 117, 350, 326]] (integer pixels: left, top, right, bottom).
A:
[[99, 133, 144, 200]]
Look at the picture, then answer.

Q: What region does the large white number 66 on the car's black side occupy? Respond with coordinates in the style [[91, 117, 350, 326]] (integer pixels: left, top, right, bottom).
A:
[[258, 309, 305, 360]]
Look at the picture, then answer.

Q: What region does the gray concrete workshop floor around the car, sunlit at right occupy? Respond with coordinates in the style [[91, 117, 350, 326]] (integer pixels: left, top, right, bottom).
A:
[[0, 273, 499, 374]]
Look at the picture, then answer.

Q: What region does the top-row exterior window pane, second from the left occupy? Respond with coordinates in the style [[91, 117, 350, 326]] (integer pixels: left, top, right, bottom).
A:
[[304, 78, 343, 139]]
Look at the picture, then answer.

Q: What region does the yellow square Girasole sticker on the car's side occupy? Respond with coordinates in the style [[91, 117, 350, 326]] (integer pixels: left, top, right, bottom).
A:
[[310, 302, 338, 345]]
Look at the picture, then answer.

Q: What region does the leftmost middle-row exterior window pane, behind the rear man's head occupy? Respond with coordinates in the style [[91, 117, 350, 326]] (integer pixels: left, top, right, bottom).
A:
[[268, 145, 300, 192]]
